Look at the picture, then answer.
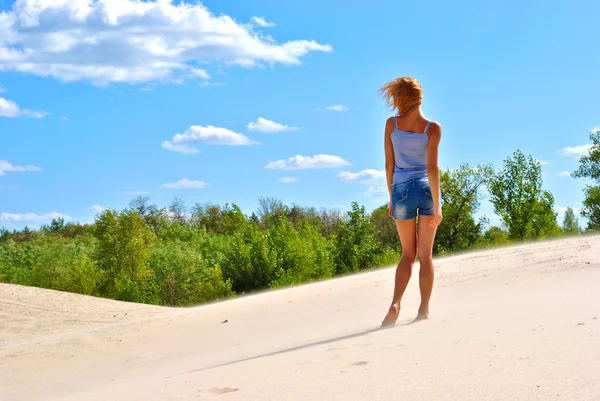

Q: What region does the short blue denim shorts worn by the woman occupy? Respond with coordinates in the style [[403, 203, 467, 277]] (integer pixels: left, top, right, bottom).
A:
[[392, 177, 433, 220]]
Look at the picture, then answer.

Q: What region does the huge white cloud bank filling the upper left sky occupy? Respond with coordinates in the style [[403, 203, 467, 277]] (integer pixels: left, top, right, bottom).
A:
[[0, 0, 332, 84]]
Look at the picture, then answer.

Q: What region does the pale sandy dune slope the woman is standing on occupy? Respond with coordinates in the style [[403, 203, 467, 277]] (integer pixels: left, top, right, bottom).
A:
[[0, 236, 600, 401]]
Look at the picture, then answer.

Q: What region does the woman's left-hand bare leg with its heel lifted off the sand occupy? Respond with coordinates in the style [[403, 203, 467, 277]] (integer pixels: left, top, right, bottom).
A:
[[381, 219, 417, 327]]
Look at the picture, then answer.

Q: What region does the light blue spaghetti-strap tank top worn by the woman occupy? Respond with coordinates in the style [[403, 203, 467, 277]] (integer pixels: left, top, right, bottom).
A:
[[391, 118, 431, 184]]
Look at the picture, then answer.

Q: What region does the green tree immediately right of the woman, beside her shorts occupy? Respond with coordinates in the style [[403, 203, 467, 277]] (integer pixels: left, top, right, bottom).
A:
[[435, 164, 493, 253]]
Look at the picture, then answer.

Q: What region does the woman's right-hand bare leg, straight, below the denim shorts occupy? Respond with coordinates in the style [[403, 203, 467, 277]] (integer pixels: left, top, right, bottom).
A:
[[417, 216, 437, 320]]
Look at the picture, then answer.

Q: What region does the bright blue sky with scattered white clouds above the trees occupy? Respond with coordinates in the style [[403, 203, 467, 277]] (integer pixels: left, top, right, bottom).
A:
[[0, 0, 600, 229]]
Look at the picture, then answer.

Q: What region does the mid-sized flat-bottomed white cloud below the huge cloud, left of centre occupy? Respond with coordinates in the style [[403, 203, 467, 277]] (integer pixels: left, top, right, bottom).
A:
[[162, 125, 258, 154]]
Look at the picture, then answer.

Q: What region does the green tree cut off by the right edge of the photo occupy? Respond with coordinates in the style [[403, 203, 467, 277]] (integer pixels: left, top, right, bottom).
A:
[[572, 130, 600, 230]]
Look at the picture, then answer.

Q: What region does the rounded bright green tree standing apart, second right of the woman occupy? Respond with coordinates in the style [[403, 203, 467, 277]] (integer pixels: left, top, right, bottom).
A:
[[489, 150, 557, 240]]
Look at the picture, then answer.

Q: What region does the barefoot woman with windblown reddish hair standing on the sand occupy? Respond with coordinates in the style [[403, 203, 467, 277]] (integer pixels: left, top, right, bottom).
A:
[[381, 77, 442, 327]]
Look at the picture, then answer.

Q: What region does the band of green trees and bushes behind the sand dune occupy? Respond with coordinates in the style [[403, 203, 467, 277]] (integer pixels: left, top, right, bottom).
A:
[[0, 136, 600, 306]]
